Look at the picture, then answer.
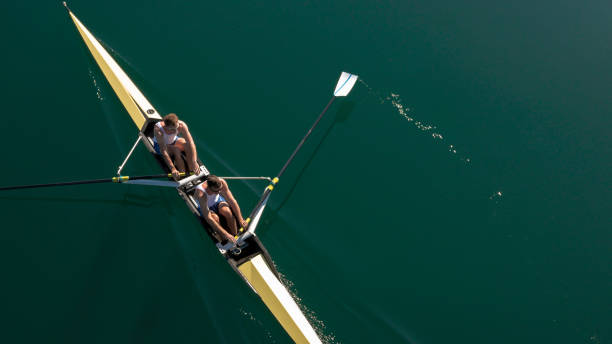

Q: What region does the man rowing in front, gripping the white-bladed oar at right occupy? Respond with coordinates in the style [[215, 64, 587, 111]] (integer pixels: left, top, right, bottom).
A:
[[195, 174, 247, 243]]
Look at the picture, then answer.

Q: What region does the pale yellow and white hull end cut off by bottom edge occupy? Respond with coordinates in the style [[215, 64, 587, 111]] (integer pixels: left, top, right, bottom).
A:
[[238, 254, 321, 344]]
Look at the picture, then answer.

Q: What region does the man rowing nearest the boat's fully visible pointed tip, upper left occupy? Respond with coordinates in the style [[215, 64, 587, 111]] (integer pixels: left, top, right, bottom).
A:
[[153, 113, 200, 180]]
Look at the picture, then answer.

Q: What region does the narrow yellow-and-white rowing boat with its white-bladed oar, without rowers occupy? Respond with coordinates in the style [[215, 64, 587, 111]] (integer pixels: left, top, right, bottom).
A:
[[64, 2, 357, 343]]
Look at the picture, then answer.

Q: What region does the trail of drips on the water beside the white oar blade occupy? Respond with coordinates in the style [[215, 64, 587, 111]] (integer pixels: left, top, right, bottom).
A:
[[359, 79, 472, 165]]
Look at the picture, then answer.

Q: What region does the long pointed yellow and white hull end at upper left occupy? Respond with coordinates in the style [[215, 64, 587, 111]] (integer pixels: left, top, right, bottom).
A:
[[69, 11, 161, 131]]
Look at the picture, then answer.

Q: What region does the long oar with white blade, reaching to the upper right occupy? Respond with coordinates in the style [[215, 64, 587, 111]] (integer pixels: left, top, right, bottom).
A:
[[236, 72, 358, 245]]
